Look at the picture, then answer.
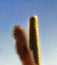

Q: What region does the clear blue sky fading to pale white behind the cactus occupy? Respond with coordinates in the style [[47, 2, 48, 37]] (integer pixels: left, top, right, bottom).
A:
[[0, 0, 57, 65]]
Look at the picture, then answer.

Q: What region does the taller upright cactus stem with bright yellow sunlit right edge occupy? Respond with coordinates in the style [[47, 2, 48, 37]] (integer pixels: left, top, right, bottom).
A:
[[29, 16, 40, 65]]
